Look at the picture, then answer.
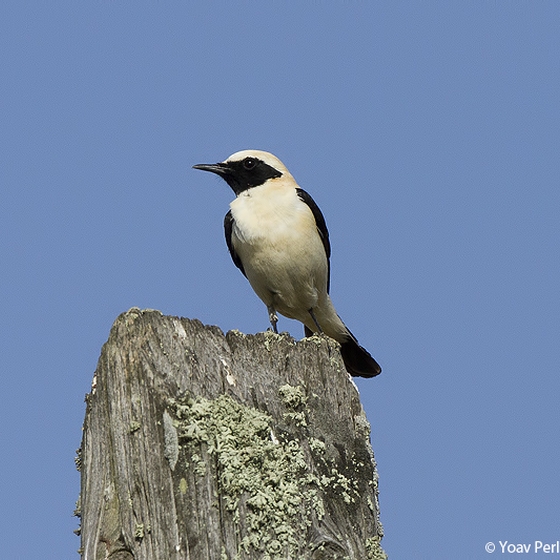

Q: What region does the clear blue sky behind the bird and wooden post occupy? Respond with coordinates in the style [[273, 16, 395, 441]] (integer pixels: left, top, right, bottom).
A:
[[0, 0, 560, 560]]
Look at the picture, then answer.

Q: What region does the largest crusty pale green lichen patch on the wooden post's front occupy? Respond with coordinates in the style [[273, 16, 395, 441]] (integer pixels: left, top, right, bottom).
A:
[[171, 391, 324, 560]]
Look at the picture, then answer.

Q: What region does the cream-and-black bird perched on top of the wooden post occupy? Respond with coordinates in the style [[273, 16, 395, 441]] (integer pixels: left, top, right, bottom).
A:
[[193, 150, 381, 377]]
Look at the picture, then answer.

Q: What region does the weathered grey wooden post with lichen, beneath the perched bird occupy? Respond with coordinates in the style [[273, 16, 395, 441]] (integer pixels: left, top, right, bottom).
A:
[[77, 308, 386, 560]]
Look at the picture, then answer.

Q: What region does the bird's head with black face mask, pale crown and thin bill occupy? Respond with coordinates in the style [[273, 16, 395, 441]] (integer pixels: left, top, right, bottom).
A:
[[193, 150, 293, 194]]
